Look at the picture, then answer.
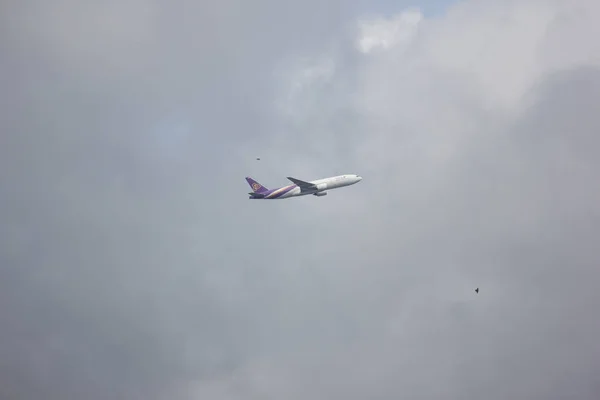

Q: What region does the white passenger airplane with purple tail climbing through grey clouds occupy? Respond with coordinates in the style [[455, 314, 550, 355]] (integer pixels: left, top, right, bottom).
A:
[[246, 175, 362, 200]]
